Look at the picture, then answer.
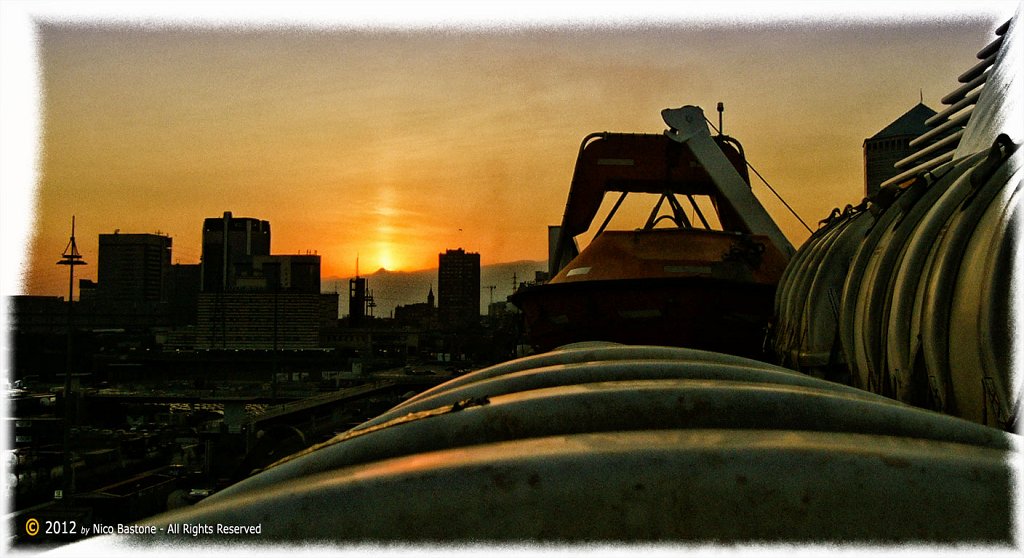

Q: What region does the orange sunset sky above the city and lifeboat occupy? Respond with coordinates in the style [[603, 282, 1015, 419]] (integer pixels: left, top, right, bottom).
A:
[[3, 2, 1017, 296]]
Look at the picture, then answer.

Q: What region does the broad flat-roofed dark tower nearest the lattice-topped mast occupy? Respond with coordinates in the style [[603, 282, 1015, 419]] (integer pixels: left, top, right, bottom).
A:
[[95, 231, 171, 313]]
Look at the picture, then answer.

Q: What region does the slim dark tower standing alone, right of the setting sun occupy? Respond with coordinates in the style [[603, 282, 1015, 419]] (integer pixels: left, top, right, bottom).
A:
[[437, 248, 480, 330]]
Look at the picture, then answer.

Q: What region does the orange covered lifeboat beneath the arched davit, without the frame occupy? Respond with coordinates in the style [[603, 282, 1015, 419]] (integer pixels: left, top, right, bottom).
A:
[[510, 230, 785, 358]]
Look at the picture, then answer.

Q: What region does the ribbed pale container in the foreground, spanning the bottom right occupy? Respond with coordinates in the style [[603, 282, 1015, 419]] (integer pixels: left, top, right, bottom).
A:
[[70, 343, 1012, 544]]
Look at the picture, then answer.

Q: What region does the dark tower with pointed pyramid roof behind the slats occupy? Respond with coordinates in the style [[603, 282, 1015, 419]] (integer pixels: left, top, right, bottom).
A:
[[863, 103, 935, 198]]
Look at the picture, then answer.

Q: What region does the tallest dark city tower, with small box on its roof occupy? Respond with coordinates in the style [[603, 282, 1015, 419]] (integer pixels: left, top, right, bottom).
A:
[[201, 211, 270, 293]]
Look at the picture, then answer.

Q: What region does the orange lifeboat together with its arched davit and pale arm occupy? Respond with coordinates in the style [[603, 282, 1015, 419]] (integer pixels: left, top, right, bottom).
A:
[[511, 106, 794, 357]]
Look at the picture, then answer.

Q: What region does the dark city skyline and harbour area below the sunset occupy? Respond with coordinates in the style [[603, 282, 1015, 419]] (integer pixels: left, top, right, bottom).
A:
[[10, 207, 540, 545]]
